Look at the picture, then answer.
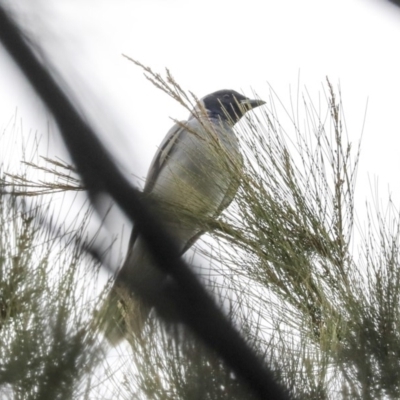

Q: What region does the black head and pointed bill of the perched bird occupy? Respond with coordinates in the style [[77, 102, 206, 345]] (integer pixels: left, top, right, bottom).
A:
[[194, 90, 265, 125]]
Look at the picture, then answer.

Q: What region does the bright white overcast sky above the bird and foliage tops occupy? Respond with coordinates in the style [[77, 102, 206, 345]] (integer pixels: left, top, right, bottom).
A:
[[0, 0, 400, 225]]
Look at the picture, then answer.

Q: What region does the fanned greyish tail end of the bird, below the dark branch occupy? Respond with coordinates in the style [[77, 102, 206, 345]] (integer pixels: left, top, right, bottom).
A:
[[95, 283, 150, 346]]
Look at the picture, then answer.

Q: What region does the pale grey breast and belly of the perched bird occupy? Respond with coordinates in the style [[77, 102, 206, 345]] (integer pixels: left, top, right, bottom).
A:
[[152, 118, 241, 227]]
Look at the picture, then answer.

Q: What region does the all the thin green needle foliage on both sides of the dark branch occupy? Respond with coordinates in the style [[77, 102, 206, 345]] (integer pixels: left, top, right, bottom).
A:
[[0, 60, 400, 400]]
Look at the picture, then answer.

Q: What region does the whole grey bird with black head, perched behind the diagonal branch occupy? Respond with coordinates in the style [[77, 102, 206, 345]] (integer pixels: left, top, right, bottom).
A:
[[98, 89, 265, 346]]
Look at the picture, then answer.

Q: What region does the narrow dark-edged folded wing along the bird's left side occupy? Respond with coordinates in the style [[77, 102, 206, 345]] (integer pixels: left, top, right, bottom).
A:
[[129, 122, 185, 249]]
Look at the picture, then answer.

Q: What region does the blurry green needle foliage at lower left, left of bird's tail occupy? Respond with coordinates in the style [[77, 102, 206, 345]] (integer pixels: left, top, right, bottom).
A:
[[0, 151, 104, 400]]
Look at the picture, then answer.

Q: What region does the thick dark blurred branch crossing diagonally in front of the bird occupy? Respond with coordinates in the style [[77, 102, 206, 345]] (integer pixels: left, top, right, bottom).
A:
[[0, 6, 289, 400]]
